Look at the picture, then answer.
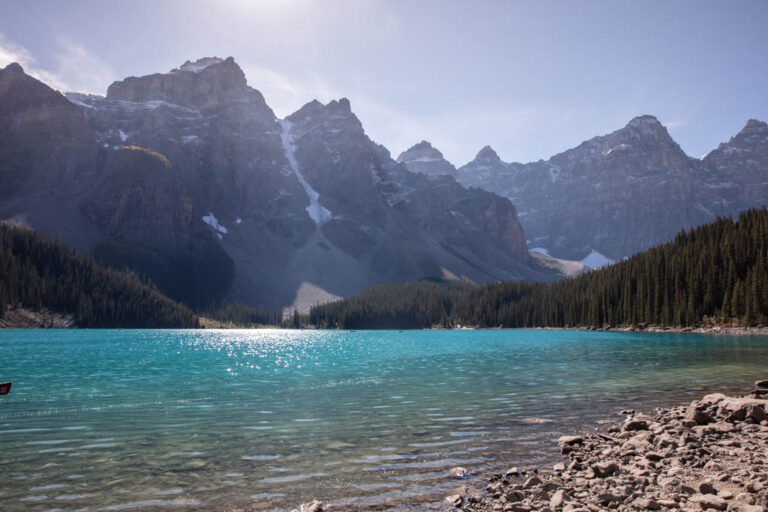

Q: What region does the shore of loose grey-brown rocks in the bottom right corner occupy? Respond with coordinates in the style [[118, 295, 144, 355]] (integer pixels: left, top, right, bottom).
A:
[[445, 381, 768, 512]]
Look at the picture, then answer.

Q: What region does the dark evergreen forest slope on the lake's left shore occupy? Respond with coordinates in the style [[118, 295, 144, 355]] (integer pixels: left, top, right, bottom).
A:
[[0, 223, 199, 328]]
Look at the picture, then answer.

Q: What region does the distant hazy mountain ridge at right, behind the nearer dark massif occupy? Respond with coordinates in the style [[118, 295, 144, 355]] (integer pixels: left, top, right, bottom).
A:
[[406, 115, 768, 267]]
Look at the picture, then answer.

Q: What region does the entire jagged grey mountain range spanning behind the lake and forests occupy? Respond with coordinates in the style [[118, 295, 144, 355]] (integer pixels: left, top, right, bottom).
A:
[[0, 57, 768, 311]]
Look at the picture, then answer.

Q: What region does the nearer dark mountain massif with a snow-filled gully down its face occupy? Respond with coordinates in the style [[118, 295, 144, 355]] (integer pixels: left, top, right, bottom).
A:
[[0, 58, 557, 309]]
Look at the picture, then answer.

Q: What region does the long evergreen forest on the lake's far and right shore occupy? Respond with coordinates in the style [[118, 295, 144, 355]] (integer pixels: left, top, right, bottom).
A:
[[310, 207, 768, 328]]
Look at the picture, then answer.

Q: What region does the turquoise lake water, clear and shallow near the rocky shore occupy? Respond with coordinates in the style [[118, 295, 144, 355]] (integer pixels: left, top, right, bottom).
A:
[[0, 330, 768, 511]]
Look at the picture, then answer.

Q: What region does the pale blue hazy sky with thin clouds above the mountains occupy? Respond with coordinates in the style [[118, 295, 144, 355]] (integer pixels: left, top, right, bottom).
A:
[[0, 0, 768, 165]]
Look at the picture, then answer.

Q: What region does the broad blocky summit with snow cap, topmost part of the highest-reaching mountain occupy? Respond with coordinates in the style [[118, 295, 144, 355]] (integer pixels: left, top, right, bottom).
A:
[[107, 57, 249, 109]]
